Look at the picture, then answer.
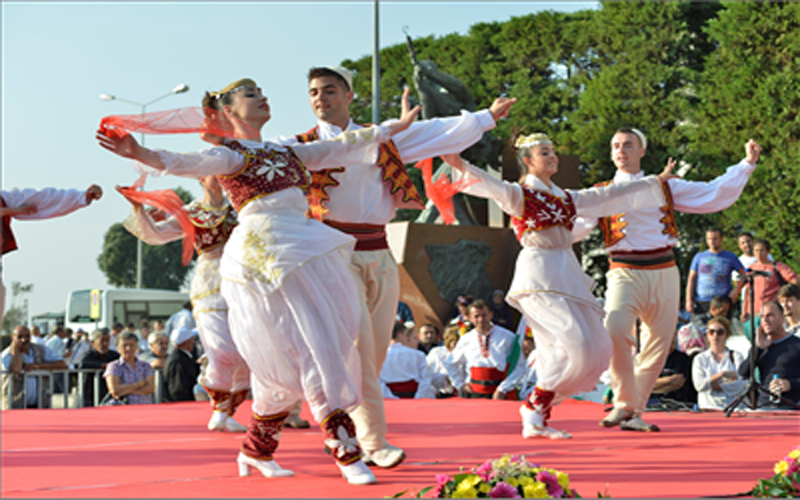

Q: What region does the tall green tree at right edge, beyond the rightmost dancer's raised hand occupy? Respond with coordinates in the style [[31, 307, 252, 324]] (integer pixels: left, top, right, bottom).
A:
[[687, 2, 800, 270]]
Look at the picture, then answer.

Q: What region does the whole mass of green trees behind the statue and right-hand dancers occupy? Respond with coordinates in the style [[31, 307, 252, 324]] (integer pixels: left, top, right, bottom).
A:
[[343, 2, 800, 290]]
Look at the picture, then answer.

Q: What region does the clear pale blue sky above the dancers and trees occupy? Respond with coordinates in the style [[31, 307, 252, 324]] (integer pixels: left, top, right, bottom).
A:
[[0, 1, 599, 315]]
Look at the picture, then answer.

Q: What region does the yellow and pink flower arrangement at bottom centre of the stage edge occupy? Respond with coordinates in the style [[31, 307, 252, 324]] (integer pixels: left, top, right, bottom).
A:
[[399, 455, 580, 498]]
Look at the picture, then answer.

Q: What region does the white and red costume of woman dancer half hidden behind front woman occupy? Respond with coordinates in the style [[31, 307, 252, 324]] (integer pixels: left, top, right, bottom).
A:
[[124, 200, 250, 432]]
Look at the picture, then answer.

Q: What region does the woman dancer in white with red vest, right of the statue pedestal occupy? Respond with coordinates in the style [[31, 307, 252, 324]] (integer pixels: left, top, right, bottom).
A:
[[442, 134, 669, 439]]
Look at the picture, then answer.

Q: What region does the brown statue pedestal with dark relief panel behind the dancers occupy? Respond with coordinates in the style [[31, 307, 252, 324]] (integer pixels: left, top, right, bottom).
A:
[[386, 221, 520, 328]]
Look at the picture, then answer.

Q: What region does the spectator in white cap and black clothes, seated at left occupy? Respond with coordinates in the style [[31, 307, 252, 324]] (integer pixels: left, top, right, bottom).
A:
[[164, 326, 200, 402]]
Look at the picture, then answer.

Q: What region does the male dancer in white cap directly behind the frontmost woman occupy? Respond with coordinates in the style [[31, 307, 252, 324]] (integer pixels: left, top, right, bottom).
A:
[[290, 66, 516, 468]]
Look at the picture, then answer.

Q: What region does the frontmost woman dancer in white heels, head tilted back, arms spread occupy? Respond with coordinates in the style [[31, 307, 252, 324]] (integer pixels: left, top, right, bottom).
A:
[[96, 79, 419, 484]]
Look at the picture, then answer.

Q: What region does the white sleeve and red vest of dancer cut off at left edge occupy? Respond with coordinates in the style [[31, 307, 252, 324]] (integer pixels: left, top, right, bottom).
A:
[[0, 188, 96, 322]]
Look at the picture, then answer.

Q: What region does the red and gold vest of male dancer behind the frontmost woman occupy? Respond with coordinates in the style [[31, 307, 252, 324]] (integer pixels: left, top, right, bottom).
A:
[[295, 127, 424, 221]]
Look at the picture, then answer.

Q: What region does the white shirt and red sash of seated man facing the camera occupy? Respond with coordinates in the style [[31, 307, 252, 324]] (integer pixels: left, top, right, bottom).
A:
[[445, 325, 525, 400]]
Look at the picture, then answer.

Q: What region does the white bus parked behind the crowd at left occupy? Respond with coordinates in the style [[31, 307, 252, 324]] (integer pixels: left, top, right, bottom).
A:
[[64, 289, 189, 332]]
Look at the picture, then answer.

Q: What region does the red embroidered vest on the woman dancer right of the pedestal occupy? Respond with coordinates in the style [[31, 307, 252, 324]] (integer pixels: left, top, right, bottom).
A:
[[511, 186, 576, 241]]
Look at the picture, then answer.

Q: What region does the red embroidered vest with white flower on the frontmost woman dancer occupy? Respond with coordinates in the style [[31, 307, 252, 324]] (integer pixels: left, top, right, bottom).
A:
[[217, 140, 309, 212]]
